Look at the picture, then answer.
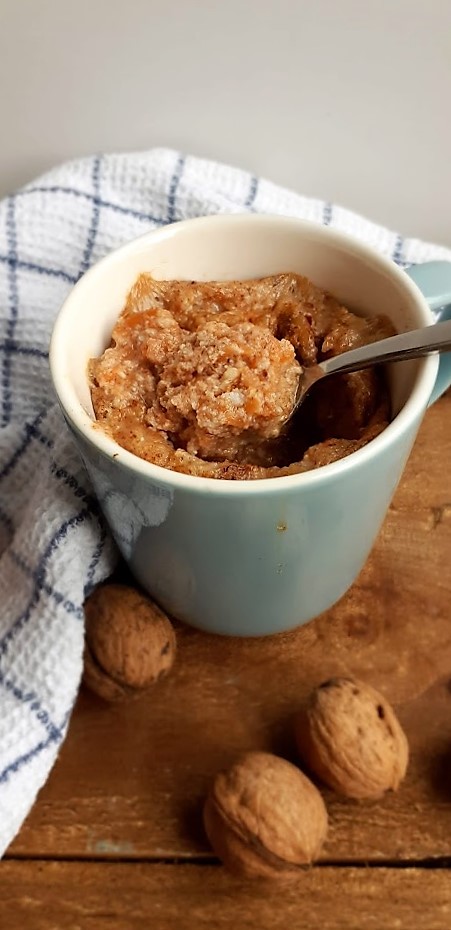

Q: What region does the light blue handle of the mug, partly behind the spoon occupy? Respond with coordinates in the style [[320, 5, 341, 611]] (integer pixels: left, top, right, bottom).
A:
[[405, 262, 451, 404]]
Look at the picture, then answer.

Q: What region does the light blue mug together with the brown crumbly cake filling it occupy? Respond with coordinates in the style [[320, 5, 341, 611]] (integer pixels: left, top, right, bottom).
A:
[[50, 215, 451, 636]]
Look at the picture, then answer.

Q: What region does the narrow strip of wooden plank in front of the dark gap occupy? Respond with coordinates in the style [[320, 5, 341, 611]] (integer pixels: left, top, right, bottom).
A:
[[0, 862, 451, 930]]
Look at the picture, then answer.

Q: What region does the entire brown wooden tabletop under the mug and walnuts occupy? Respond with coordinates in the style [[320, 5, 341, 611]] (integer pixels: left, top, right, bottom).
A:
[[0, 393, 451, 930]]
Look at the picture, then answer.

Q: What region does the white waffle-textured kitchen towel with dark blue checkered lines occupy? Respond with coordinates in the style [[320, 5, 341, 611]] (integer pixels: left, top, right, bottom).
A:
[[0, 149, 451, 854]]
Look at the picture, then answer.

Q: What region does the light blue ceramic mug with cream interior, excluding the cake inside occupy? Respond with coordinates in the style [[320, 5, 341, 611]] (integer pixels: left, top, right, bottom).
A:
[[50, 215, 451, 636]]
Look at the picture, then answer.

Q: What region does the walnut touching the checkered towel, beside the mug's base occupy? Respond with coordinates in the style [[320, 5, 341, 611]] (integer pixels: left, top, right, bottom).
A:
[[83, 584, 176, 701]]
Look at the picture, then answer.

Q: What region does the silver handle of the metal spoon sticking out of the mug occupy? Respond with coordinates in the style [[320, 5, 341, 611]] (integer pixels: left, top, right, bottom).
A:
[[319, 320, 451, 375]]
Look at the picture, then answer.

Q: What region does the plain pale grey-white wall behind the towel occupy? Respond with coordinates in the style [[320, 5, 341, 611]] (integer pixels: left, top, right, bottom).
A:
[[0, 0, 451, 246]]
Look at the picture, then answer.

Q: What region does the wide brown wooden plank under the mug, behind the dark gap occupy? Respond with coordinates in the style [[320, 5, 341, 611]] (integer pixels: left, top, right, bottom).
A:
[[10, 395, 451, 860]]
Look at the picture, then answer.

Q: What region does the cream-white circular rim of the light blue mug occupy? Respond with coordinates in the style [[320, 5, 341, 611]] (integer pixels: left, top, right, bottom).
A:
[[49, 213, 439, 496]]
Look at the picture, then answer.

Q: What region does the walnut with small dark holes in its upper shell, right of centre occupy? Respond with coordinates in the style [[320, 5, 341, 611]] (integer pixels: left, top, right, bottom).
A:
[[295, 678, 409, 798]]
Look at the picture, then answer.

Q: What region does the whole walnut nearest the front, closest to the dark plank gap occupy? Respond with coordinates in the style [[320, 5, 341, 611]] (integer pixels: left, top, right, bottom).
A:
[[204, 752, 327, 879]]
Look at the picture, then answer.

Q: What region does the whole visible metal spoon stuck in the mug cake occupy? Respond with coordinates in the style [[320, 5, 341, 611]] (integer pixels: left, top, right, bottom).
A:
[[284, 320, 451, 425]]
